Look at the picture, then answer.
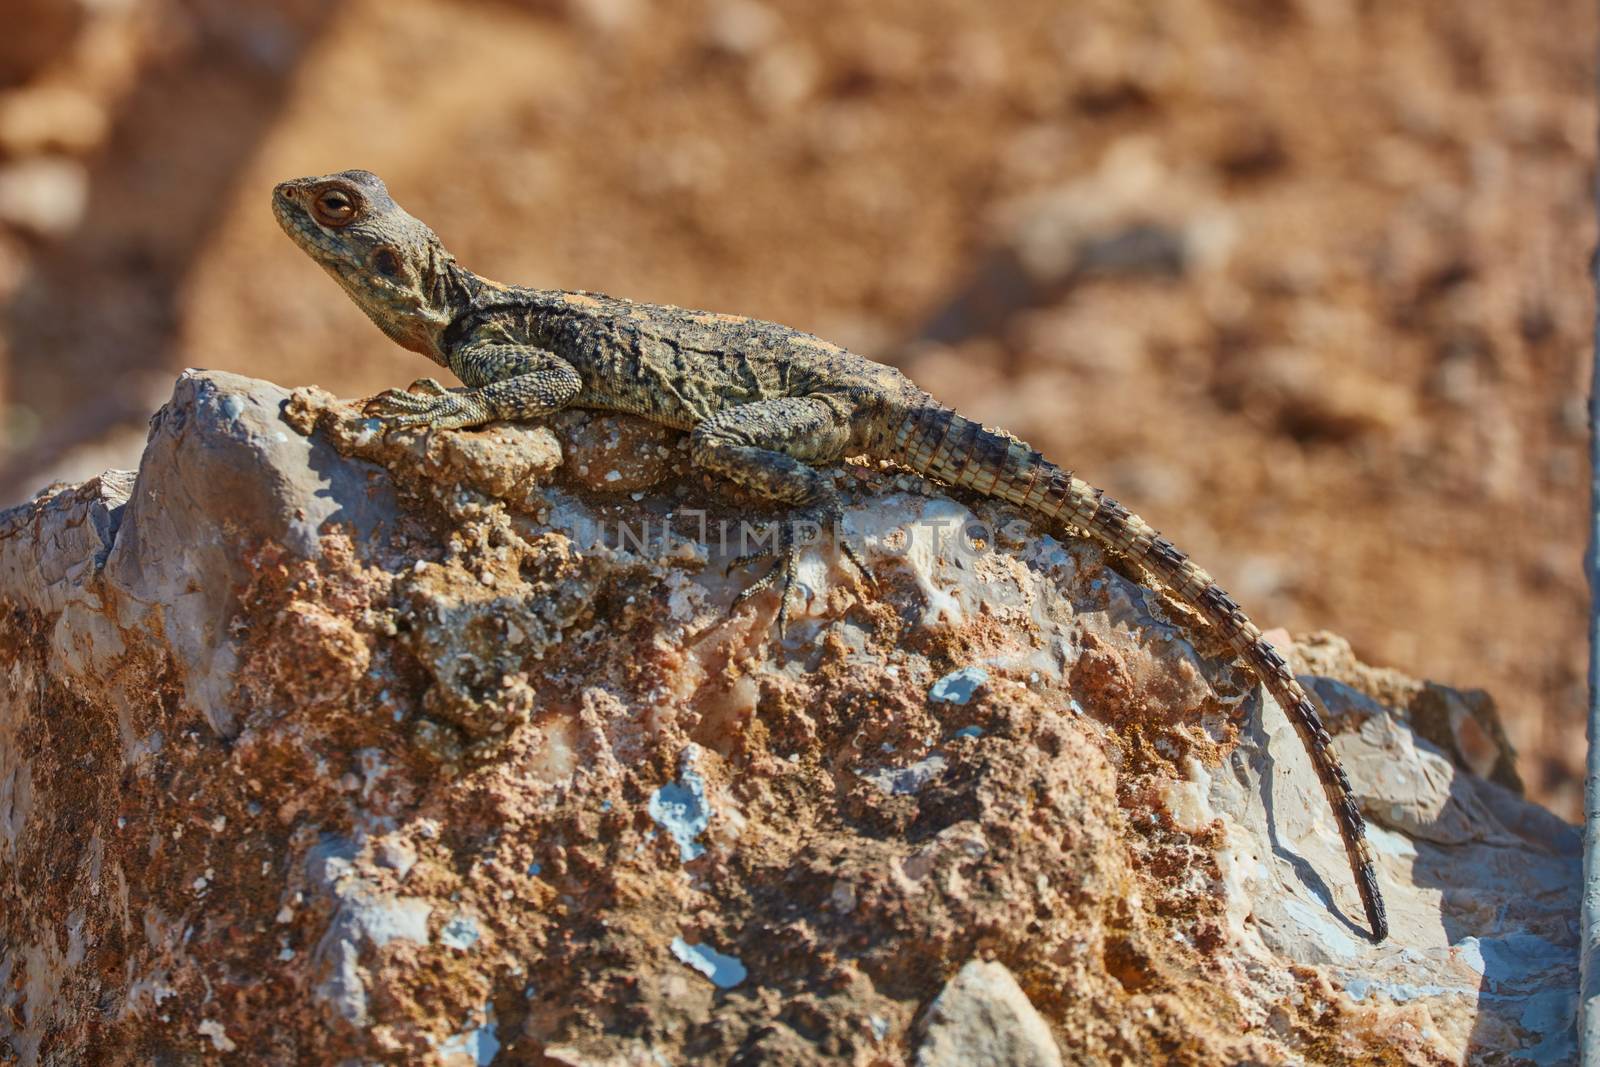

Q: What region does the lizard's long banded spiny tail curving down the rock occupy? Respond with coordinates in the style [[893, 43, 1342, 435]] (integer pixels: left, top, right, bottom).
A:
[[885, 398, 1389, 942]]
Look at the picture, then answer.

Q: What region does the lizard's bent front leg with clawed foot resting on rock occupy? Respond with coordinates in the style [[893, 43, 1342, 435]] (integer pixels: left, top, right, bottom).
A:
[[366, 344, 582, 430]]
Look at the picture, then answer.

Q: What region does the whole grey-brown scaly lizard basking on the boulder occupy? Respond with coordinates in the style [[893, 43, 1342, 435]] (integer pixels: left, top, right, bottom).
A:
[[272, 170, 1389, 942]]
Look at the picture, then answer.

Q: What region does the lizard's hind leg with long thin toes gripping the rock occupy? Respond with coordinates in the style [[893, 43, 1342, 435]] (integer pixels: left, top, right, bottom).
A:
[[690, 397, 867, 640]]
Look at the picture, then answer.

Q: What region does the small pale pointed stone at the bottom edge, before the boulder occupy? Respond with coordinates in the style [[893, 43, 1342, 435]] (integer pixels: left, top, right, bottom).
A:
[[917, 960, 1061, 1067]]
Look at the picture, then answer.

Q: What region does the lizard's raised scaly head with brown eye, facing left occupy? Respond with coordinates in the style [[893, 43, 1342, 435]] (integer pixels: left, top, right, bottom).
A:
[[272, 171, 464, 362]]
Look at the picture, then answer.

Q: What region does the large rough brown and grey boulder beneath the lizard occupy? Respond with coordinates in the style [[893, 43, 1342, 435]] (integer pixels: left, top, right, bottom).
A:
[[0, 373, 1579, 1067]]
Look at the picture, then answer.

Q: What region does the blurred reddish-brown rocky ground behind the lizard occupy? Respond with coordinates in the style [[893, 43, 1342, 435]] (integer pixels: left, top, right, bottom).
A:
[[0, 0, 1597, 817]]
